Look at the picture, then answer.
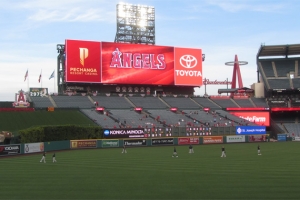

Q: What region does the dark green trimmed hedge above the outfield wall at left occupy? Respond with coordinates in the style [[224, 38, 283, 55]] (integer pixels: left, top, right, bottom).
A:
[[19, 125, 102, 143]]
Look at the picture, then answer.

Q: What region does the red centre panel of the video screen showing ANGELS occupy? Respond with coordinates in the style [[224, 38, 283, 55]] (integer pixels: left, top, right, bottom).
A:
[[102, 42, 174, 85]]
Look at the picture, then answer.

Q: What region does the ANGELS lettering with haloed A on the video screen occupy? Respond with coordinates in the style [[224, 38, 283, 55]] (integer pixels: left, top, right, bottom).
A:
[[110, 48, 166, 70]]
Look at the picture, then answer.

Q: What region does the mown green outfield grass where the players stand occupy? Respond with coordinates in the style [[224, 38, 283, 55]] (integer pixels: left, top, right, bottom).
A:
[[0, 142, 300, 199]]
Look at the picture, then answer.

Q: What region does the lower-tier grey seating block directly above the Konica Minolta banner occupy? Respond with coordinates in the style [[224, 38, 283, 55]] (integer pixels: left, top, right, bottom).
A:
[[109, 110, 162, 128]]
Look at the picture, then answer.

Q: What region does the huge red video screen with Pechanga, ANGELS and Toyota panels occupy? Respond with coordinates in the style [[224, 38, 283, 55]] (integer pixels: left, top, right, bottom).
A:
[[65, 40, 203, 86]]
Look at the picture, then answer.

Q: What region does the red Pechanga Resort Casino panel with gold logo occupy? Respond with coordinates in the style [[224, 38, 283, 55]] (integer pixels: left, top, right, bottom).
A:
[[65, 40, 101, 83]]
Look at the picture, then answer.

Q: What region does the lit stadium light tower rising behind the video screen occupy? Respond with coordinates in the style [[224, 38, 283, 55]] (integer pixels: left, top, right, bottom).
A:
[[115, 3, 155, 45]]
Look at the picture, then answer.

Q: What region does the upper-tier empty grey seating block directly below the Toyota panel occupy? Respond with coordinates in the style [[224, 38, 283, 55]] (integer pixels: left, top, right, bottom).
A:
[[162, 97, 200, 109]]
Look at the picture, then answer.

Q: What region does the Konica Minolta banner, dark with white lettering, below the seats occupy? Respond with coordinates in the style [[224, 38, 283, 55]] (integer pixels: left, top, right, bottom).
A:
[[103, 128, 148, 138]]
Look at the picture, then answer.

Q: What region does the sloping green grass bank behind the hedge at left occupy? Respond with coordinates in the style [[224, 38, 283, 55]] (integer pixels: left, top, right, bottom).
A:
[[0, 110, 95, 131]]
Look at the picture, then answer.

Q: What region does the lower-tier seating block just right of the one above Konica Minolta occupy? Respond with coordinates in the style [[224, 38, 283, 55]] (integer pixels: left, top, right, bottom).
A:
[[148, 109, 193, 126]]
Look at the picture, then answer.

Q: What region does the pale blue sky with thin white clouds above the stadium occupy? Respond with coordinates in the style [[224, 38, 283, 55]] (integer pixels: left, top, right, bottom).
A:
[[0, 0, 300, 101]]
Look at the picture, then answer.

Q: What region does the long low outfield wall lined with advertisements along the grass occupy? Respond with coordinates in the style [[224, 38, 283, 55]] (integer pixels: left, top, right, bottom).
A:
[[0, 135, 276, 158]]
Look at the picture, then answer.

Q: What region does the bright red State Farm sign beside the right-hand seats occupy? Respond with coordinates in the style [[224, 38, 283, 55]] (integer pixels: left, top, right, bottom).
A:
[[229, 112, 270, 126]]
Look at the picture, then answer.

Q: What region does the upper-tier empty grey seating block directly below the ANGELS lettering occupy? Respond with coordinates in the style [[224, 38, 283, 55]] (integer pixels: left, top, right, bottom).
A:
[[128, 97, 168, 109]]
